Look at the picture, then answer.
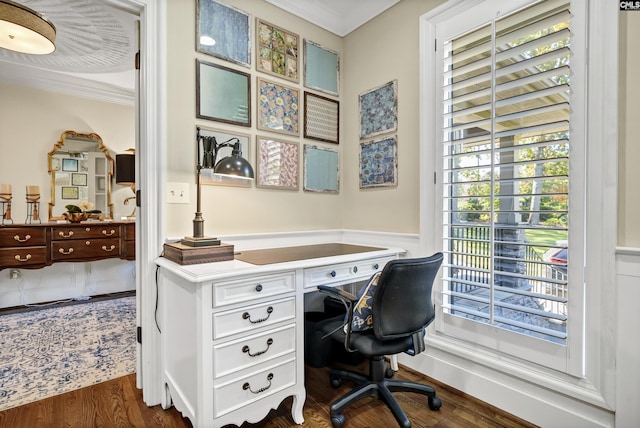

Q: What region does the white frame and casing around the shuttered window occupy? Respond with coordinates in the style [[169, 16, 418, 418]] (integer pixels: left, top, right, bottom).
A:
[[420, 0, 618, 398]]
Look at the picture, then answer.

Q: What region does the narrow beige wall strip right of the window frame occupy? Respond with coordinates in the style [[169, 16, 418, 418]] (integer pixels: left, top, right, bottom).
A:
[[618, 12, 640, 247]]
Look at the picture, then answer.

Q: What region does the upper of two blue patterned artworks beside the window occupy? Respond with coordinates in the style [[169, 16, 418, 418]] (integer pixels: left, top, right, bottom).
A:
[[359, 80, 398, 138]]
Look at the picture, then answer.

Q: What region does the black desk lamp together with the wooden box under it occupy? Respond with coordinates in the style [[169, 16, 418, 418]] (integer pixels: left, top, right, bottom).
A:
[[164, 127, 254, 264]]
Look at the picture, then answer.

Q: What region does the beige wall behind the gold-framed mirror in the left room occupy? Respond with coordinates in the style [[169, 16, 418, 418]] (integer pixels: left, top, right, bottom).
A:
[[0, 83, 135, 223]]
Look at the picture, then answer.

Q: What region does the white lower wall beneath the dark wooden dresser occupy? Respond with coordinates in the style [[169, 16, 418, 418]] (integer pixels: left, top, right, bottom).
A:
[[0, 259, 136, 308]]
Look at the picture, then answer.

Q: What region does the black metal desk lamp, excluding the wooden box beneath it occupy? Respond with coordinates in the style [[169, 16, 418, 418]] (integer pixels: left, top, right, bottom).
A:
[[180, 127, 254, 247]]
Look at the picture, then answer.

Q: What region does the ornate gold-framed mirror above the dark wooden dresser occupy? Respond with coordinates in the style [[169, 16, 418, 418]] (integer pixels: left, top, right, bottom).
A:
[[48, 131, 114, 220]]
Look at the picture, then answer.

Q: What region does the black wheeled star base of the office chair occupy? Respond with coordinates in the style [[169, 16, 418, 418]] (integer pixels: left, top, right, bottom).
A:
[[329, 356, 442, 428]]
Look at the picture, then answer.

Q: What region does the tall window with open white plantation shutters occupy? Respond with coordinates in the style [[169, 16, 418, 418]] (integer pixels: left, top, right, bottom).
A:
[[424, 0, 585, 371]]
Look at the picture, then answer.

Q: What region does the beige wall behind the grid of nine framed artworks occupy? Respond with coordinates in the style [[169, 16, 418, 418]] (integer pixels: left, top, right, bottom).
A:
[[166, 0, 346, 237]]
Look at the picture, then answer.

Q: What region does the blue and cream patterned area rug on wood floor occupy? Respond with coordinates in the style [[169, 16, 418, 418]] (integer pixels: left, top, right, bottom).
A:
[[0, 296, 136, 411]]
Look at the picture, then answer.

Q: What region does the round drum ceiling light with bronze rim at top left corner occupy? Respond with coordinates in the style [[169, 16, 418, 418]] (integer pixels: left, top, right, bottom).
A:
[[0, 0, 56, 55]]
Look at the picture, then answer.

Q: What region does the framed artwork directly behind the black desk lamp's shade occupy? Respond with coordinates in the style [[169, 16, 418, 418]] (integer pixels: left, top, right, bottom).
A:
[[200, 127, 253, 187]]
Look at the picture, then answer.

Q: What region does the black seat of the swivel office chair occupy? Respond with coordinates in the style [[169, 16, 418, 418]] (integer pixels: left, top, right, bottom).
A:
[[317, 315, 413, 357]]
